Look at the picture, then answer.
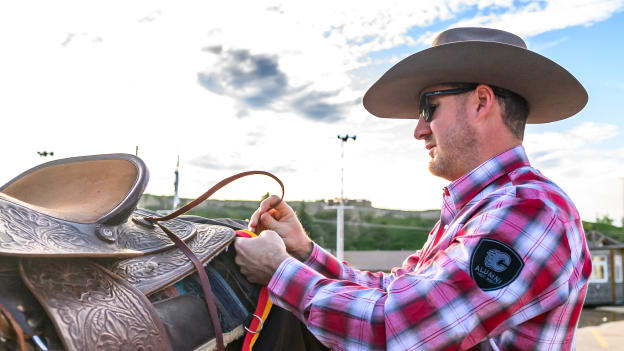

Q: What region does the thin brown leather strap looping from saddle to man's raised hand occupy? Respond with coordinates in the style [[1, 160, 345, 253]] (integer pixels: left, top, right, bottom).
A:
[[145, 171, 284, 351]]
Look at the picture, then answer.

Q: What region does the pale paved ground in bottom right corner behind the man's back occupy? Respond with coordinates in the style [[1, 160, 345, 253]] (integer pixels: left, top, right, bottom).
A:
[[576, 321, 624, 351]]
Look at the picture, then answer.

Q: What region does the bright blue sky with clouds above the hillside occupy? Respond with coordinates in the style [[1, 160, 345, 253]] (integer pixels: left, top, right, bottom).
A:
[[0, 0, 624, 223]]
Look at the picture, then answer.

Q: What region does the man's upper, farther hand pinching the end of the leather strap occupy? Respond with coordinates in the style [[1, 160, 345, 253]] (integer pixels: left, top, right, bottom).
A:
[[249, 195, 312, 261]]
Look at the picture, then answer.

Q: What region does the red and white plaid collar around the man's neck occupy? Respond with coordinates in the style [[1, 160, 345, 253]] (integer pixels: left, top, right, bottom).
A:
[[444, 145, 530, 210]]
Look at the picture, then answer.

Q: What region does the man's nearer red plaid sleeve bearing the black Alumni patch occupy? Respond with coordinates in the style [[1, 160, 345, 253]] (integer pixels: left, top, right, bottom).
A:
[[268, 201, 573, 350]]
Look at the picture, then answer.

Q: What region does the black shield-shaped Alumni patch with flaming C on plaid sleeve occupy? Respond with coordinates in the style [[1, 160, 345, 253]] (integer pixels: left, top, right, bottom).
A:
[[470, 238, 524, 291]]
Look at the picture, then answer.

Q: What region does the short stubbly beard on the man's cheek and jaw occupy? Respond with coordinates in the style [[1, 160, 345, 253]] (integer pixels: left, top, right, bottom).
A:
[[429, 106, 478, 181]]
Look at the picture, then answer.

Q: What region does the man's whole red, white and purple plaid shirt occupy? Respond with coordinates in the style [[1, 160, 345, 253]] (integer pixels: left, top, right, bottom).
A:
[[268, 146, 591, 350]]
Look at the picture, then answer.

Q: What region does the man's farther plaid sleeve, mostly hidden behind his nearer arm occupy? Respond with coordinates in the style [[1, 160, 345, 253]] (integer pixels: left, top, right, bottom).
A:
[[304, 243, 420, 290]]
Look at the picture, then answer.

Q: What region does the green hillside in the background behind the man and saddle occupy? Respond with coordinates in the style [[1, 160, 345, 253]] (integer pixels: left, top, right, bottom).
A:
[[139, 194, 624, 250]]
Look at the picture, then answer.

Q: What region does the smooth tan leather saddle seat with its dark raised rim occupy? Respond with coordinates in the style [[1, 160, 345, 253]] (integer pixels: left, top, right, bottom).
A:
[[0, 155, 148, 223]]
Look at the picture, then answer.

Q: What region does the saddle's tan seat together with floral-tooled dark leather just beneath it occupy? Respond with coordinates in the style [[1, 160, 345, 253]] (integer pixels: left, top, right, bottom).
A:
[[0, 154, 197, 258]]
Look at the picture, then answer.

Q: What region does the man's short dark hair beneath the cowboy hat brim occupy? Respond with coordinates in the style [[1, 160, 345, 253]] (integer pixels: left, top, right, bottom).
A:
[[449, 83, 529, 140]]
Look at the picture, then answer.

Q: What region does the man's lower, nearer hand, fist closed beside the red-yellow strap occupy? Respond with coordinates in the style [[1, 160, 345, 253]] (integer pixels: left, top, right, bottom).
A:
[[234, 230, 290, 285]]
